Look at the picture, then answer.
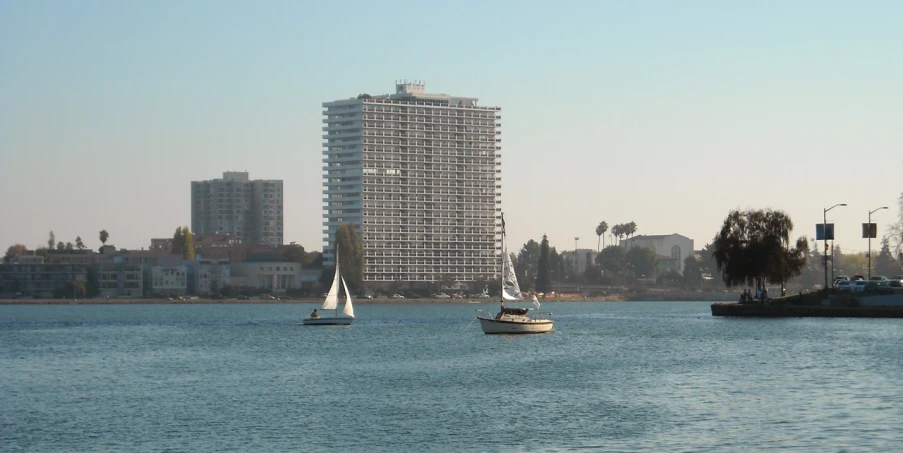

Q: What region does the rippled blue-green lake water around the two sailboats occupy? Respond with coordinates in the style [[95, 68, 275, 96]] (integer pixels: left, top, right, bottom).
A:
[[0, 302, 903, 452]]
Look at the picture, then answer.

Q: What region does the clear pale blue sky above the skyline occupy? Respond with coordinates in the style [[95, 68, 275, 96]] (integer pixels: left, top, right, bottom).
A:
[[0, 0, 903, 252]]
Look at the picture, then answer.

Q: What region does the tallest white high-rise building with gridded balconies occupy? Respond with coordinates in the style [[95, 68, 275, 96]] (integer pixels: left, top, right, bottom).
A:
[[323, 82, 501, 282]]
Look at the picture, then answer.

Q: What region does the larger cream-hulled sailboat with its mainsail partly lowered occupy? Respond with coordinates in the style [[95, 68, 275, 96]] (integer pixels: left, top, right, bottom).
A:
[[477, 215, 553, 334]]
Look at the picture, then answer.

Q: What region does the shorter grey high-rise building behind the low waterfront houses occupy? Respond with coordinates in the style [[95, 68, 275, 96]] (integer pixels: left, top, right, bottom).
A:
[[191, 171, 283, 245]]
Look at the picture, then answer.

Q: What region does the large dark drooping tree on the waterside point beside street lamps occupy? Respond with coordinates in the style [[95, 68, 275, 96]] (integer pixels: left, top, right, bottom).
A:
[[714, 209, 808, 288]]
